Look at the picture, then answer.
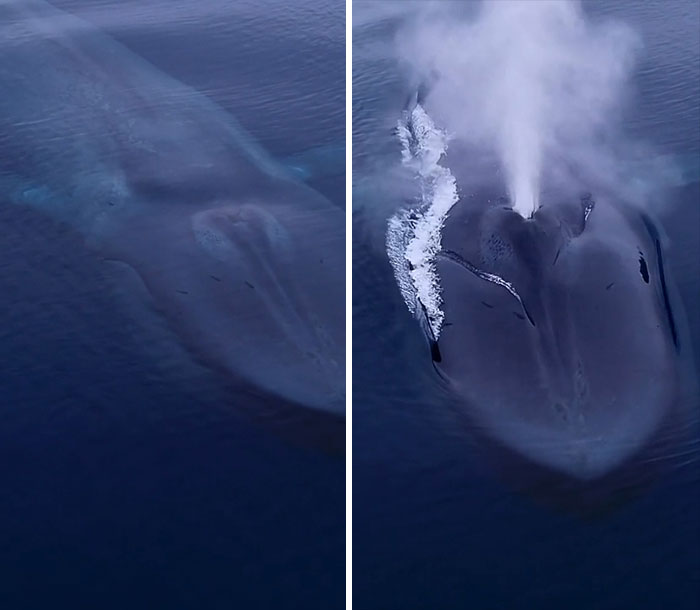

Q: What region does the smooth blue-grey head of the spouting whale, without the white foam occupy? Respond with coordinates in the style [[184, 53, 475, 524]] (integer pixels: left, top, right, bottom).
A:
[[422, 197, 691, 481]]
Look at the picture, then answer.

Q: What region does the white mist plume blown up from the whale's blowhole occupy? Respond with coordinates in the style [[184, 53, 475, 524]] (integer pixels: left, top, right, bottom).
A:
[[399, 0, 638, 217]]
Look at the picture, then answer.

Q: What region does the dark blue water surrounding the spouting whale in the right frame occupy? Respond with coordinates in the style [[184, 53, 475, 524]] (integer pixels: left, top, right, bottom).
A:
[[353, 0, 700, 610]]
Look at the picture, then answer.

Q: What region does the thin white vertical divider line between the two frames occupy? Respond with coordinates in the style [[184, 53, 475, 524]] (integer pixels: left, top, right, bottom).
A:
[[345, 0, 352, 610]]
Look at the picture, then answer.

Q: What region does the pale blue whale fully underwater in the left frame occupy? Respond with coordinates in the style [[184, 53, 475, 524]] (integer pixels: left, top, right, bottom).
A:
[[0, 0, 345, 418]]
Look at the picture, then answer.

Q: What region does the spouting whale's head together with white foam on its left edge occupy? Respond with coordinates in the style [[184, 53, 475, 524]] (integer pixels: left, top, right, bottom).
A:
[[387, 105, 698, 494]]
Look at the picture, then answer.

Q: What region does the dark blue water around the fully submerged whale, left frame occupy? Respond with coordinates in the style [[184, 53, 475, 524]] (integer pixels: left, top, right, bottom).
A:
[[0, 0, 345, 610]]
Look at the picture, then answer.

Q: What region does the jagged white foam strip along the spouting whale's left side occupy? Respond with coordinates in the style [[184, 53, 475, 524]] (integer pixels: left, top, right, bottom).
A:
[[386, 104, 458, 339]]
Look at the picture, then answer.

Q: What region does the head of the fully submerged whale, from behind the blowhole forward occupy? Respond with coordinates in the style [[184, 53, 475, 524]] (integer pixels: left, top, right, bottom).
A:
[[100, 183, 345, 417]]
